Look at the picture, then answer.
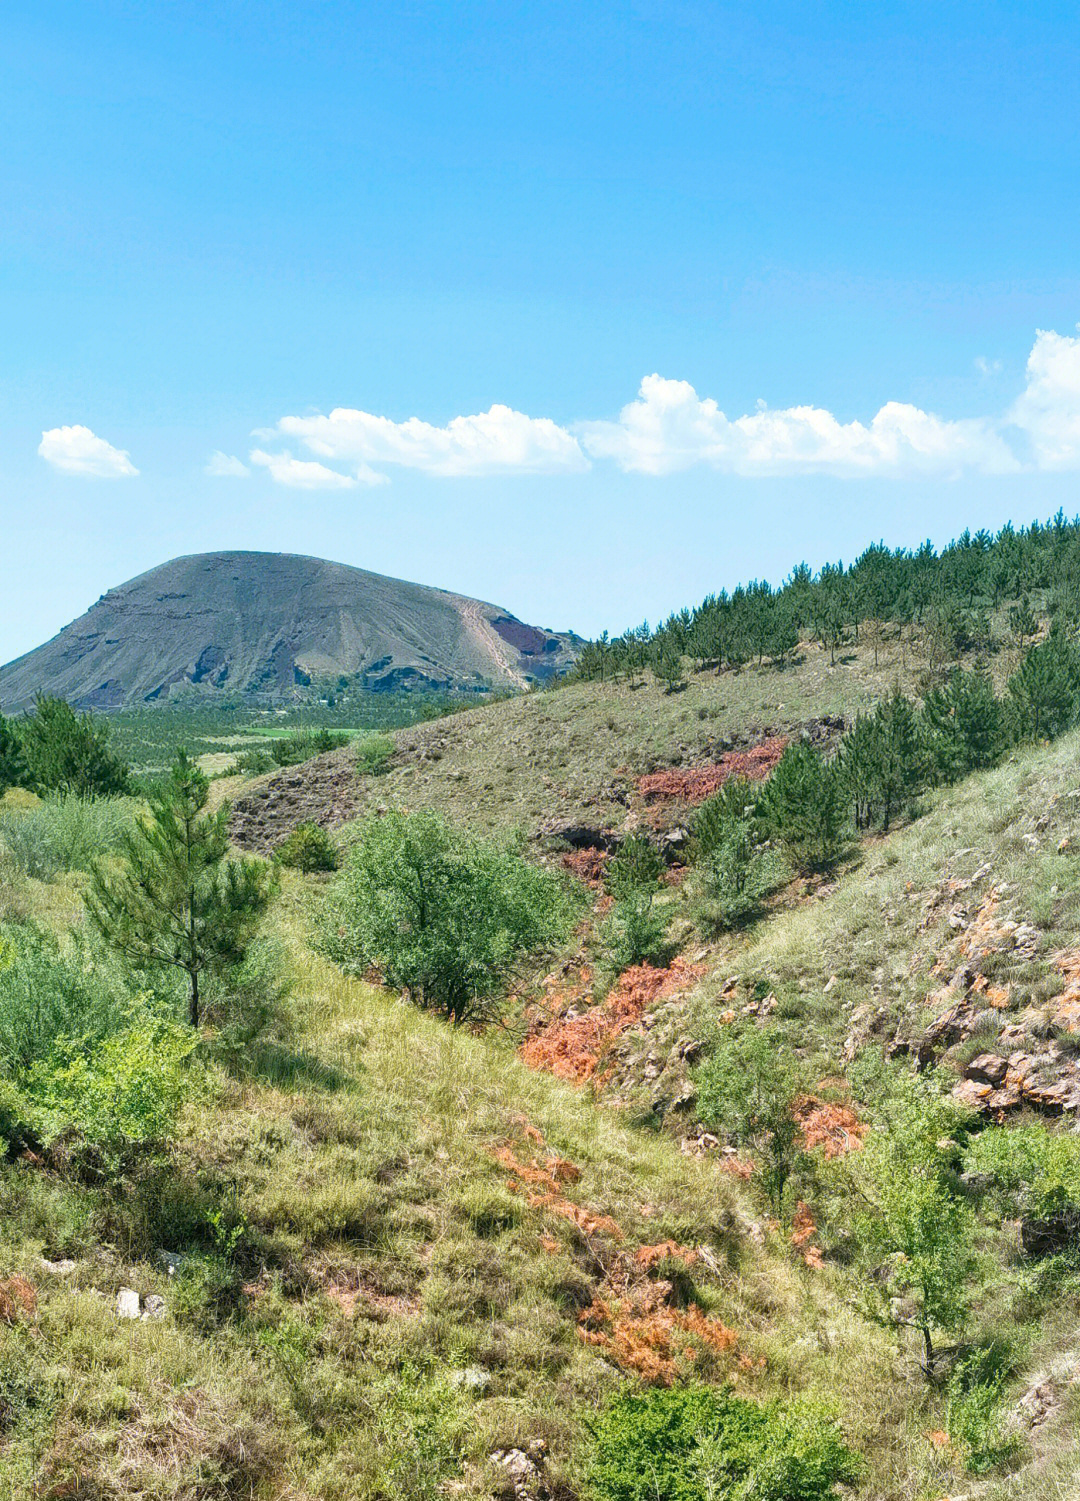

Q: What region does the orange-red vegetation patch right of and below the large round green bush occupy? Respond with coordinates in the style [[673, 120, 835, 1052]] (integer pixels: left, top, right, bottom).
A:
[[521, 958, 704, 1084]]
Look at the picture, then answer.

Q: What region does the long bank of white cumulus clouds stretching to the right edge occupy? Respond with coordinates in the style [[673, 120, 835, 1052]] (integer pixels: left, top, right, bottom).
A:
[[250, 332, 1080, 489]]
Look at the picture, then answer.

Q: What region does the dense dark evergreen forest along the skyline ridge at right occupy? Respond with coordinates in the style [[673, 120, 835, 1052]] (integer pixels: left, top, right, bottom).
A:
[[573, 512, 1080, 687]]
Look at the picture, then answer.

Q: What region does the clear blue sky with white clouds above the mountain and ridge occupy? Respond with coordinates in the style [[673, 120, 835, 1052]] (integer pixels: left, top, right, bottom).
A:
[[0, 0, 1080, 660]]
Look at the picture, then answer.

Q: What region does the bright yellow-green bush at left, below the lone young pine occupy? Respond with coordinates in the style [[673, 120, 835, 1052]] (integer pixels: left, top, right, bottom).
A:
[[23, 1021, 198, 1171]]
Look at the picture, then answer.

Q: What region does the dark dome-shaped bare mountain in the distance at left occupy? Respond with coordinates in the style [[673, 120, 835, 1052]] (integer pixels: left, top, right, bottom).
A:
[[0, 552, 575, 710]]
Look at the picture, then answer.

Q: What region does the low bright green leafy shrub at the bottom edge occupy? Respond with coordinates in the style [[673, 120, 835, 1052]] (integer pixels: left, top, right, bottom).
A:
[[587, 1385, 861, 1501]]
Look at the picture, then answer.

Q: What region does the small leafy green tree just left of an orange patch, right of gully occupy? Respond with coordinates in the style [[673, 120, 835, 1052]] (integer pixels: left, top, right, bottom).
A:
[[696, 1027, 803, 1214]]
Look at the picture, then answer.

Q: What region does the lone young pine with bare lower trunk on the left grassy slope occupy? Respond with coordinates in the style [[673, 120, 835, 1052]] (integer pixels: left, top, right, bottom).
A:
[[84, 751, 273, 1027]]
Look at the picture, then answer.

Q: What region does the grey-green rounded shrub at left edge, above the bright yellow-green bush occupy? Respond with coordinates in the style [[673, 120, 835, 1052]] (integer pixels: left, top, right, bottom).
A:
[[0, 926, 134, 1078]]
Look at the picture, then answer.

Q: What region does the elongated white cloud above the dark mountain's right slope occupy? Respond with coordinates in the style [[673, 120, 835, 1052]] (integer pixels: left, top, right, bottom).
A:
[[278, 405, 590, 476]]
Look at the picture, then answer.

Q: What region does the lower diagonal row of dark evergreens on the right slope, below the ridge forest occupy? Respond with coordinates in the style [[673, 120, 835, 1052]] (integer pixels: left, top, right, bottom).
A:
[[695, 629, 1080, 900]]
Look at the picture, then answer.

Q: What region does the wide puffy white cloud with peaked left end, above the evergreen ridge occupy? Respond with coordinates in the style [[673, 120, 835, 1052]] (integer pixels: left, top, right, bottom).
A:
[[578, 375, 1017, 476]]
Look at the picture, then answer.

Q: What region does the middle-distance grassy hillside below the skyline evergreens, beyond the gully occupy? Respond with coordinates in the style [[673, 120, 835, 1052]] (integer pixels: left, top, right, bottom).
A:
[[228, 627, 972, 847]]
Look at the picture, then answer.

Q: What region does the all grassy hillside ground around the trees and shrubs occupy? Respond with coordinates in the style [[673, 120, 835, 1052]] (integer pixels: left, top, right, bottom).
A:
[[0, 627, 1080, 1501]]
